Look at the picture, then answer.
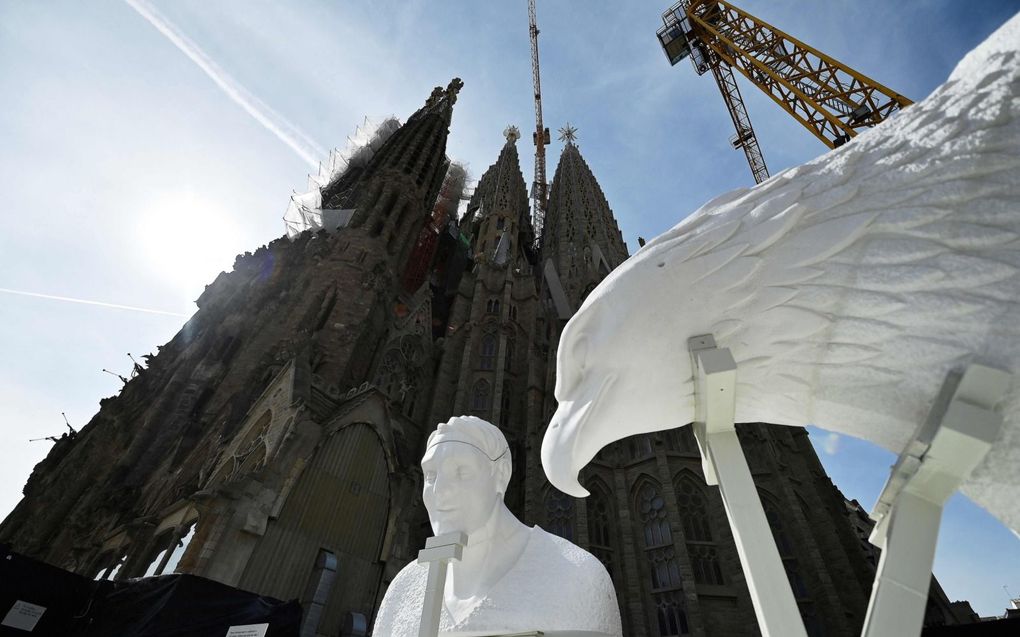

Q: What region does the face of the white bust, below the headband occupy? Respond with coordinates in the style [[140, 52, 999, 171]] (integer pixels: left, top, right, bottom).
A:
[[421, 440, 505, 536]]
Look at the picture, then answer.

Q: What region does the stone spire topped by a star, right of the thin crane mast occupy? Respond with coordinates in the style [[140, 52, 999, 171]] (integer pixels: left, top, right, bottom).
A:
[[542, 137, 628, 310]]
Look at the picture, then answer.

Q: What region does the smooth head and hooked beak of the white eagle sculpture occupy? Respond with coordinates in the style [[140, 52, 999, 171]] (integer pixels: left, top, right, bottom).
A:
[[542, 247, 698, 497]]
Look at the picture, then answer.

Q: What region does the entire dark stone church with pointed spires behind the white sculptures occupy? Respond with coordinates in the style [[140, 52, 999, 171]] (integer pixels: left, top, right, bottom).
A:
[[0, 81, 954, 637]]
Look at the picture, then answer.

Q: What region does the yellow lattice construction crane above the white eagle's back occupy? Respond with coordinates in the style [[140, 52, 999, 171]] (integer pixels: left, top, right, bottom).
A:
[[656, 0, 913, 183]]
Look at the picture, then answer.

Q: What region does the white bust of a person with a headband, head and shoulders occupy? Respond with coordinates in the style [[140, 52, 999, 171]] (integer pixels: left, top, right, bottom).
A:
[[373, 416, 621, 637]]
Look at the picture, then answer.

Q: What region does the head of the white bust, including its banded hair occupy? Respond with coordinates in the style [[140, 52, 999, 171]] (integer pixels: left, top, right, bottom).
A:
[[421, 416, 512, 536]]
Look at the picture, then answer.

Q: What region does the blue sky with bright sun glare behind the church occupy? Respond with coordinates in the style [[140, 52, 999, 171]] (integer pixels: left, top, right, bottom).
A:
[[0, 0, 1020, 615]]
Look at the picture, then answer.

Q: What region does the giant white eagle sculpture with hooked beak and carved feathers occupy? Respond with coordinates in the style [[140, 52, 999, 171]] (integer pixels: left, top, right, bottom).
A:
[[542, 12, 1020, 531]]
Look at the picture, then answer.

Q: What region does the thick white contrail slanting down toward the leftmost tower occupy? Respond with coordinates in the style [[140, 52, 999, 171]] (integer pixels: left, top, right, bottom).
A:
[[124, 0, 326, 169]]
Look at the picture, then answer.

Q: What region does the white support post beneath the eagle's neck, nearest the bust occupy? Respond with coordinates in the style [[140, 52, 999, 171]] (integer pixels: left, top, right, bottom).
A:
[[687, 334, 807, 637]]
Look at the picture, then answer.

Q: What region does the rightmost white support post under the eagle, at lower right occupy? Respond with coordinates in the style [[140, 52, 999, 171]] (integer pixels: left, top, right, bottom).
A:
[[862, 364, 1012, 637]]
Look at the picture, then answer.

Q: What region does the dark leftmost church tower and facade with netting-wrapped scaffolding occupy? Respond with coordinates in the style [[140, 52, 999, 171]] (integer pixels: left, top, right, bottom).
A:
[[0, 79, 462, 634]]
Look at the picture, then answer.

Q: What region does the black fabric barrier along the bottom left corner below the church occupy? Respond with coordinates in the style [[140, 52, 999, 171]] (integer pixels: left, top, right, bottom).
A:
[[0, 547, 301, 637]]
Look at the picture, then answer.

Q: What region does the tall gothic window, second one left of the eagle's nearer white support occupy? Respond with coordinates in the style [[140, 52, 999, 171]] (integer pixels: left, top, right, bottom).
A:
[[635, 480, 689, 637]]
